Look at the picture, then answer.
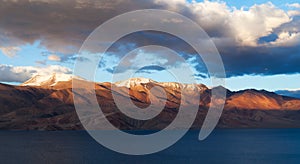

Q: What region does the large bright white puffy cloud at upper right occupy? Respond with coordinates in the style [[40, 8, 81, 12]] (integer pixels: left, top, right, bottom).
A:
[[159, 0, 292, 46]]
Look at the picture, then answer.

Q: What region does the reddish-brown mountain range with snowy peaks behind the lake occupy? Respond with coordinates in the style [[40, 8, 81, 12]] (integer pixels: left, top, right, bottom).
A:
[[0, 74, 300, 130]]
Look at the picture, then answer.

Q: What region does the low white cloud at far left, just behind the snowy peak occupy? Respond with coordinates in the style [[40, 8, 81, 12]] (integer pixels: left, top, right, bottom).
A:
[[0, 64, 72, 83]]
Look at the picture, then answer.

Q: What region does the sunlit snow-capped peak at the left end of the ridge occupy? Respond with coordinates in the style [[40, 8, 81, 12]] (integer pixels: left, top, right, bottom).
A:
[[21, 73, 80, 86]]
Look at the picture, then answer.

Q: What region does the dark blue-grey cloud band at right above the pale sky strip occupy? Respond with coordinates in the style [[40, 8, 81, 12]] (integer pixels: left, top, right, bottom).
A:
[[220, 46, 300, 77]]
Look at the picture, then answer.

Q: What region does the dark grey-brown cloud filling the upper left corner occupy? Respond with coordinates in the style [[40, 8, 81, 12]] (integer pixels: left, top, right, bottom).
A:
[[0, 0, 164, 54]]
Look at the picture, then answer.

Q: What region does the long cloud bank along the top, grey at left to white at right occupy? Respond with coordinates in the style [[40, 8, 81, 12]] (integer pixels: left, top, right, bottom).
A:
[[0, 0, 290, 50]]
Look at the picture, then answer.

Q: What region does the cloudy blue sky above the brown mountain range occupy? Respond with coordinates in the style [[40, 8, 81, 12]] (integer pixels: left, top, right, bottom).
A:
[[0, 0, 300, 91]]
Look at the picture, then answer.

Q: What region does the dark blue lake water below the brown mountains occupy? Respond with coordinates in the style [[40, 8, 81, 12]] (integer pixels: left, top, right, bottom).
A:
[[0, 129, 300, 164]]
